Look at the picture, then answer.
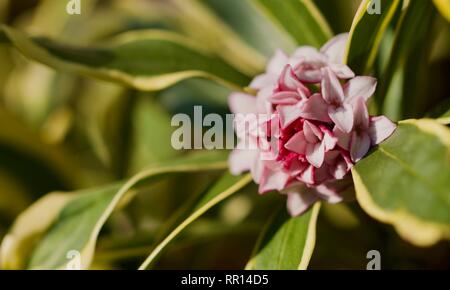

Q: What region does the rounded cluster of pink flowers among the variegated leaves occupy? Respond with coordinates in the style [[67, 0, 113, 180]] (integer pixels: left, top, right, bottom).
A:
[[229, 34, 396, 216]]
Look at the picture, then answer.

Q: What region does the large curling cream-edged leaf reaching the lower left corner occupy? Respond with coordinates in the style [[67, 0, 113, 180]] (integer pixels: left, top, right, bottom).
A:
[[0, 152, 227, 269]]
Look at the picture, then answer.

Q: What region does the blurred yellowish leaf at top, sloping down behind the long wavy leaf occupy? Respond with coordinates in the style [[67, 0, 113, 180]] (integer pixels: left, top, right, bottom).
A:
[[117, 0, 265, 75]]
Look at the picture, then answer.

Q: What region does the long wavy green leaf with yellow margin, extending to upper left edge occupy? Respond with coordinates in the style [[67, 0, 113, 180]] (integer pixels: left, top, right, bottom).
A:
[[1, 26, 250, 91]]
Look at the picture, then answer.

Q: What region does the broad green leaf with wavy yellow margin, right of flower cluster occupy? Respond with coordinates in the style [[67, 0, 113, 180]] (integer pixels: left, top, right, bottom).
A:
[[352, 119, 450, 246]]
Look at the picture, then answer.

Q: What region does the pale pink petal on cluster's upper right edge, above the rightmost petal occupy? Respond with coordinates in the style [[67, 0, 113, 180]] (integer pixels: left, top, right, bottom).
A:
[[344, 76, 377, 104]]
